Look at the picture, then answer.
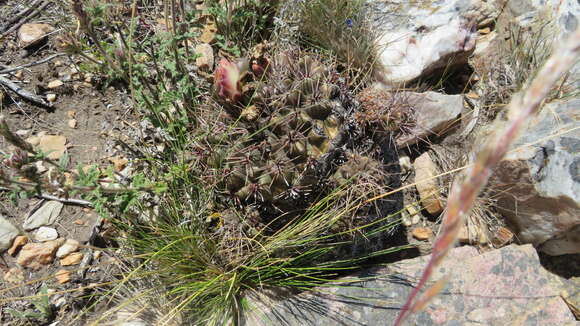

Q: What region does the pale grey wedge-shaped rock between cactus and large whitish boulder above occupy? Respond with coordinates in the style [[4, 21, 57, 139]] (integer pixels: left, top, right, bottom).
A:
[[396, 92, 463, 148]]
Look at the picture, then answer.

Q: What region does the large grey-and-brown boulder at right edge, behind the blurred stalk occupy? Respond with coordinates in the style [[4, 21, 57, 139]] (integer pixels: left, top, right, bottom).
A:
[[490, 98, 580, 255]]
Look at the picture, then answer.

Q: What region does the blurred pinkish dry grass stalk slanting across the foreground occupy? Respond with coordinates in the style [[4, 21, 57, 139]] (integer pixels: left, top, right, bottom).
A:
[[395, 29, 580, 326]]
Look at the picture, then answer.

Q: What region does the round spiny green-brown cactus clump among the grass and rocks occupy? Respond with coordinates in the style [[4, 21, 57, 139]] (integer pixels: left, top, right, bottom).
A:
[[207, 48, 398, 255]]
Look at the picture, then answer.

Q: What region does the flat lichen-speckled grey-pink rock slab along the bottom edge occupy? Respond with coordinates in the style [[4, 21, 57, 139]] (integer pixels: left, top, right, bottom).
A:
[[245, 245, 577, 326]]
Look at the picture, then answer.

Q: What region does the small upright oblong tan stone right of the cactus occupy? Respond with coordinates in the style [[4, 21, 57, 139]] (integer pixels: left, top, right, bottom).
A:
[[413, 153, 443, 215]]
